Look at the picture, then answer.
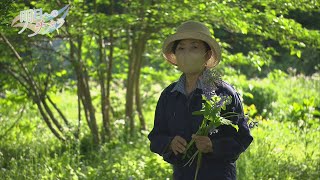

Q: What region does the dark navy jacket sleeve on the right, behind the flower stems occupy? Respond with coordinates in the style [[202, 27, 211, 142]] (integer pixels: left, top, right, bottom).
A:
[[205, 91, 253, 161]]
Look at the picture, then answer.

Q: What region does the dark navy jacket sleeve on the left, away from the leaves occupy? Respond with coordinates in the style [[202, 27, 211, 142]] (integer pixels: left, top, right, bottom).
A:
[[148, 92, 178, 164]]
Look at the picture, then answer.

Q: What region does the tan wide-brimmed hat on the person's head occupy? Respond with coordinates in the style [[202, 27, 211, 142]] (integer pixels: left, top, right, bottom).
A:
[[162, 21, 221, 68]]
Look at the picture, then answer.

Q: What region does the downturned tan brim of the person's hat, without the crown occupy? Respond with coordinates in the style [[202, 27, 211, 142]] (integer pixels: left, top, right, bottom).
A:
[[162, 32, 221, 68]]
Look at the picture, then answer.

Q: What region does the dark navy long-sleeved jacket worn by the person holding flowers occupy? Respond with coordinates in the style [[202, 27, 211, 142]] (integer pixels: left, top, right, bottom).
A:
[[148, 81, 253, 180]]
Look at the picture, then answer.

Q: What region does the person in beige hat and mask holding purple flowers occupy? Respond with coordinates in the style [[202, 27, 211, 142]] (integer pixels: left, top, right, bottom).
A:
[[148, 21, 253, 180]]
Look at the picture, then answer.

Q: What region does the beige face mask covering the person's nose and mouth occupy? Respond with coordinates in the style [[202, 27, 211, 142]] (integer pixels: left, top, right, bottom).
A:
[[176, 51, 206, 73]]
